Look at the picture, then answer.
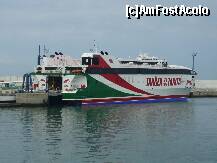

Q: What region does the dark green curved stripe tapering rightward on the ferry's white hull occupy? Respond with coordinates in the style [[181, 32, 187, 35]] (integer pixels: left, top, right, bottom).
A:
[[63, 75, 138, 100]]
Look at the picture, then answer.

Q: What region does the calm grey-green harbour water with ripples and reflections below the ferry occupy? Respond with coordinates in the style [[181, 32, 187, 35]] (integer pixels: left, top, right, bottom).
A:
[[0, 98, 217, 163]]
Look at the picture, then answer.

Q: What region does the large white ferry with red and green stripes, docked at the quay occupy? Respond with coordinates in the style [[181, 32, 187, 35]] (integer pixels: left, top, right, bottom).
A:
[[28, 48, 197, 105]]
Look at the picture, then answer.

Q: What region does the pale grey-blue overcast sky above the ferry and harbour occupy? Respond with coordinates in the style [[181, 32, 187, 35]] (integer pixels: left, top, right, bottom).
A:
[[0, 0, 217, 79]]
